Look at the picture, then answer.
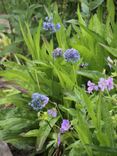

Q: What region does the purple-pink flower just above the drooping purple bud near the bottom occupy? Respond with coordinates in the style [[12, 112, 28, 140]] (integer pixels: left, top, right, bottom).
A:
[[60, 119, 71, 133]]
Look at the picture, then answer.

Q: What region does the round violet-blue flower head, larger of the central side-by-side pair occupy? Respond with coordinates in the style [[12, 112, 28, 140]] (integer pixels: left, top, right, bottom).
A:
[[64, 48, 80, 63]]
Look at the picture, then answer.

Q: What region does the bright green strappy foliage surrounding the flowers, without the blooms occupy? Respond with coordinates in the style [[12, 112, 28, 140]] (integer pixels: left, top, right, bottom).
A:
[[0, 0, 117, 156]]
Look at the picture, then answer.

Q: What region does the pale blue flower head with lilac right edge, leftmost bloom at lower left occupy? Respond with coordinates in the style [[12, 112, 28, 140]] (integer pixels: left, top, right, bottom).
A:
[[29, 93, 49, 111]]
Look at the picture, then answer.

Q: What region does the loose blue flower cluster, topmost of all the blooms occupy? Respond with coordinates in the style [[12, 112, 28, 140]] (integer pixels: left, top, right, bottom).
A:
[[43, 17, 61, 33]]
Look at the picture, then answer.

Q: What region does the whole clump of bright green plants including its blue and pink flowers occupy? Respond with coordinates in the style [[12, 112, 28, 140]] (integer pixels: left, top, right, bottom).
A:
[[0, 3, 117, 156]]
